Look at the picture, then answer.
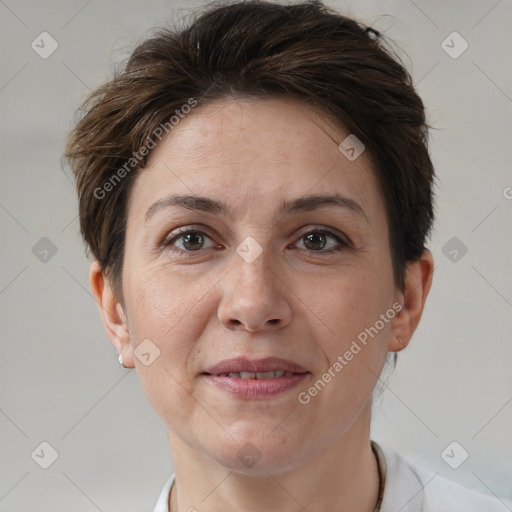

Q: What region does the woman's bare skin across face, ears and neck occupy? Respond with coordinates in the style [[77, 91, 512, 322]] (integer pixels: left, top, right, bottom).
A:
[[90, 98, 434, 512]]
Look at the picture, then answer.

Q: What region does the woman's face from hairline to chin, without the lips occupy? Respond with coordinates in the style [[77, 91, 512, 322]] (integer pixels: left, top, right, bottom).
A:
[[119, 99, 403, 472]]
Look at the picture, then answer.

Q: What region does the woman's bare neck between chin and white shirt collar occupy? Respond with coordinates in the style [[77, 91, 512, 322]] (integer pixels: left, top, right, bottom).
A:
[[169, 402, 379, 512]]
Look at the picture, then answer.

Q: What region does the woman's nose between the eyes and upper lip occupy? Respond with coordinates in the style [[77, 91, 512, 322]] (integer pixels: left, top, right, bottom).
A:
[[218, 244, 293, 332]]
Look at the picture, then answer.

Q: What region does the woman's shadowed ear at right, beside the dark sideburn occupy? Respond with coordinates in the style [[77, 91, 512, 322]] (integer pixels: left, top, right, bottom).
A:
[[388, 249, 434, 352]]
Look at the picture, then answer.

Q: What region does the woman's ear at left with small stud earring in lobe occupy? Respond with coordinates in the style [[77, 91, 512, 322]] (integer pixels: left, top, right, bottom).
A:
[[89, 260, 135, 368]]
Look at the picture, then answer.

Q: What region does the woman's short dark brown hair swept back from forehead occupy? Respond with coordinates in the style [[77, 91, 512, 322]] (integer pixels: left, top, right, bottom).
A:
[[65, 0, 434, 300]]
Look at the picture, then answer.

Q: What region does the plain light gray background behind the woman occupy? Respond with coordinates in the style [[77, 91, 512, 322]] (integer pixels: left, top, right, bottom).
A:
[[0, 0, 512, 512]]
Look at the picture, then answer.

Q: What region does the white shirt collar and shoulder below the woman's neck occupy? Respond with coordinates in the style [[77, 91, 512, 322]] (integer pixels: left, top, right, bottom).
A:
[[154, 445, 512, 512]]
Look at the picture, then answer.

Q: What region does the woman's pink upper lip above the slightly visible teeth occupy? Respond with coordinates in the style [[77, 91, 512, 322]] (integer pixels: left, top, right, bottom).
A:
[[203, 357, 308, 378]]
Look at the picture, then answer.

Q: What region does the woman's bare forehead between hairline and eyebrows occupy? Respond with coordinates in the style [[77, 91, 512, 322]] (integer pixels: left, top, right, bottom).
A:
[[129, 98, 383, 229]]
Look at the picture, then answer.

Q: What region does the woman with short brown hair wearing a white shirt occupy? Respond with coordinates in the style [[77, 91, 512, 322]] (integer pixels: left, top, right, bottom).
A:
[[67, 1, 503, 512]]
